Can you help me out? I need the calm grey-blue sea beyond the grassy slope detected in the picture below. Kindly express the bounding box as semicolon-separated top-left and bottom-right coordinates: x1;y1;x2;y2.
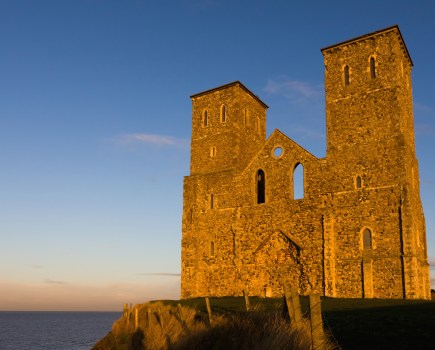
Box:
0;312;121;350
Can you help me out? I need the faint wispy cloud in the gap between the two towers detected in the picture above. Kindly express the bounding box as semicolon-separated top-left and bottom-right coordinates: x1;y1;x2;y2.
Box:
264;76;323;103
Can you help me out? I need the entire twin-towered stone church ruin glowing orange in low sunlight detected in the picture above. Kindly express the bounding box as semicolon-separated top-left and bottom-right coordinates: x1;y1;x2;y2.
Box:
181;26;430;299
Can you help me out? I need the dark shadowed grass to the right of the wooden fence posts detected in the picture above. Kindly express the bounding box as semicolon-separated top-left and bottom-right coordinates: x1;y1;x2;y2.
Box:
322;298;435;349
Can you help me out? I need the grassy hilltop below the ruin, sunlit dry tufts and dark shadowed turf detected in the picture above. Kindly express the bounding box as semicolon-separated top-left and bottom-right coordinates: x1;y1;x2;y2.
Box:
94;297;435;350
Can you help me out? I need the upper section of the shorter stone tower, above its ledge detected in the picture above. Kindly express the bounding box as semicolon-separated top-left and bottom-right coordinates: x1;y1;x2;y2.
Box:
190;81;267;175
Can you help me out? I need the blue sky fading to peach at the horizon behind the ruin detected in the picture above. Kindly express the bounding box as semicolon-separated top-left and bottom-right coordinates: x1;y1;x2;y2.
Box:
0;0;435;310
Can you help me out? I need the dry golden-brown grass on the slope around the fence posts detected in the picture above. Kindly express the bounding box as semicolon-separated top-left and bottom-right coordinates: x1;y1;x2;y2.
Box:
93;302;334;350
